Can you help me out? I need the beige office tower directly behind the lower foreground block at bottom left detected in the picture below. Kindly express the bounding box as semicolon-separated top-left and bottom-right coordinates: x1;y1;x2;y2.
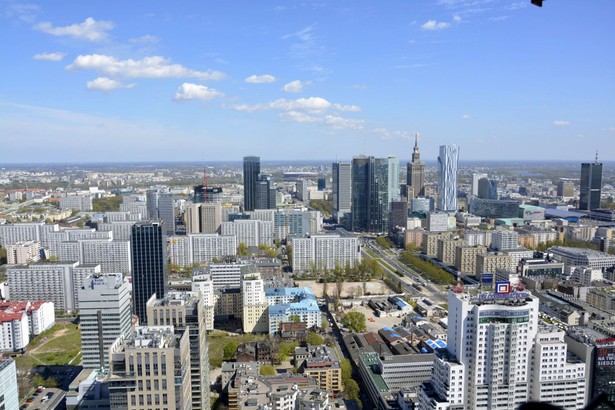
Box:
147;292;210;410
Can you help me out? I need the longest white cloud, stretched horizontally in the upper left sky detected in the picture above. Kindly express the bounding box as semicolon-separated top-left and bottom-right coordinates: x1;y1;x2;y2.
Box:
66;54;224;80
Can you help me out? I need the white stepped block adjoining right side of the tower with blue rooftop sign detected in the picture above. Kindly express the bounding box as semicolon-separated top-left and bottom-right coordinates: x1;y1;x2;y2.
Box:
530;326;589;409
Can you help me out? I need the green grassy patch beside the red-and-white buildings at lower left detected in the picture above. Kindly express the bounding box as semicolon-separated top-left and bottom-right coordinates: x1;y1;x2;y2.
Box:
15;323;81;372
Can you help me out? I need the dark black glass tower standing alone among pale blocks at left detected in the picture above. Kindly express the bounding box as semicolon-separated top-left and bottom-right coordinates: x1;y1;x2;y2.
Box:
130;222;167;324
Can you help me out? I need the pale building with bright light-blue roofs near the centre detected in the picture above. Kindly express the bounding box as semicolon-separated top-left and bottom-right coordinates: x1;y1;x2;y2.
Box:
265;287;322;334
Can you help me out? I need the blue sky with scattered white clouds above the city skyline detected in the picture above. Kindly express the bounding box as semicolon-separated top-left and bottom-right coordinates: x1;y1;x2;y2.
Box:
0;0;615;163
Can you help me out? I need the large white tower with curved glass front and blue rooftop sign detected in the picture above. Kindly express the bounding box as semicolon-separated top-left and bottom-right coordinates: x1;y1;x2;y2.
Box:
421;289;538;410
